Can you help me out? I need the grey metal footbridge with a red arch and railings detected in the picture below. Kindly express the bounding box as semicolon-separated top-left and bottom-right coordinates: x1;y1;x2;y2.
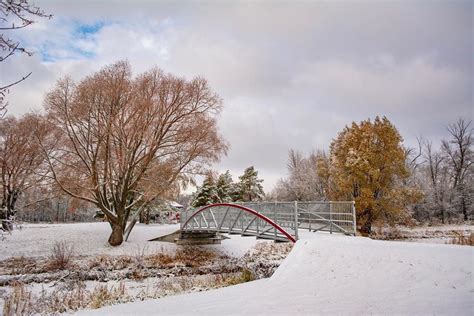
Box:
180;201;356;242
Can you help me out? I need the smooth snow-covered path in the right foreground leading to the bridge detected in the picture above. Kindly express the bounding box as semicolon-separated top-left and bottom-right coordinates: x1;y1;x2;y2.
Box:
85;233;474;315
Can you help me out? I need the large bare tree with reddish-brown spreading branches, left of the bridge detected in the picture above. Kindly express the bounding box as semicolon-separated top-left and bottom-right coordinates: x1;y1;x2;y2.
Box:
41;61;227;246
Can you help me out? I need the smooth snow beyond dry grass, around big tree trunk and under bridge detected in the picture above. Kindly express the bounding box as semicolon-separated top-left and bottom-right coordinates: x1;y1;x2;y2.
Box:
0;222;262;260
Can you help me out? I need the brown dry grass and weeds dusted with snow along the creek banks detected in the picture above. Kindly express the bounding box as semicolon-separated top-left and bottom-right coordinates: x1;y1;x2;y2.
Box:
0;243;292;315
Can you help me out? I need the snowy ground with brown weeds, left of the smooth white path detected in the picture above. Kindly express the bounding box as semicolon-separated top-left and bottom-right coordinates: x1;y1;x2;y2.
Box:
0;223;291;314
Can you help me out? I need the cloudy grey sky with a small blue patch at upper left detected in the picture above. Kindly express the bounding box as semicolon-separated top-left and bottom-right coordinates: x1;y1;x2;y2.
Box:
0;0;474;191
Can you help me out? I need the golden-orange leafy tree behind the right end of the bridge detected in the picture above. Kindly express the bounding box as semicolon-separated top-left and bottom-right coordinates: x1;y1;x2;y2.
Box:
330;117;419;234
